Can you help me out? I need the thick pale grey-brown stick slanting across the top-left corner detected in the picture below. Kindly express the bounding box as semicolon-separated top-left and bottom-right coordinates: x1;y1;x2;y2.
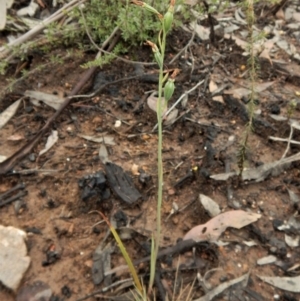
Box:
0;0;86;59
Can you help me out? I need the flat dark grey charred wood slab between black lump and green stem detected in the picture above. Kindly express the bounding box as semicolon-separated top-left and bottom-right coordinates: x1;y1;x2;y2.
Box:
105;163;142;204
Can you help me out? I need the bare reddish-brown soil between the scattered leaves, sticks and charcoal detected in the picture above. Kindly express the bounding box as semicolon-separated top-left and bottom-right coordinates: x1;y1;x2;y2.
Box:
0;1;300;301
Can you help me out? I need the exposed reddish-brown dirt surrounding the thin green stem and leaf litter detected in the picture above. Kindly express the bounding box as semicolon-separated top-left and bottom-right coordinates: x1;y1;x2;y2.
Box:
0;15;300;301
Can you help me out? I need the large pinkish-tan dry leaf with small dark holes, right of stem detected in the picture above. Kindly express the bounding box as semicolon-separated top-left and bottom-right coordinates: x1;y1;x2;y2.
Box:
183;210;261;242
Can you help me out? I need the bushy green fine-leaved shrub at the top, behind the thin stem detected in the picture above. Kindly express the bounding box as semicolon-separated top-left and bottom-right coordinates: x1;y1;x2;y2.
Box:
75;0;190;46
